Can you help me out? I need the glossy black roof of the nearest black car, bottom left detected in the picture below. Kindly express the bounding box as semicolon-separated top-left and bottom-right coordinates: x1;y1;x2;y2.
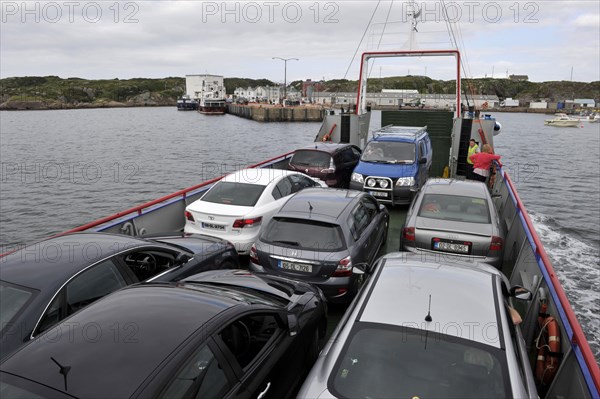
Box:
2;283;258;397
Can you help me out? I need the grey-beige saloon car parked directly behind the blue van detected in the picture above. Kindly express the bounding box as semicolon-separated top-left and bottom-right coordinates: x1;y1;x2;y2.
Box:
400;179;505;268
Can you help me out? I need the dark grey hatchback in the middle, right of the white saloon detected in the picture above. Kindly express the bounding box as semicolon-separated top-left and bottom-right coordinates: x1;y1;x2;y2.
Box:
249;188;389;303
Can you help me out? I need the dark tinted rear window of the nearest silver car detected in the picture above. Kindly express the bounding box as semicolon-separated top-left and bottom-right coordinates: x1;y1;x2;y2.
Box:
328;324;511;398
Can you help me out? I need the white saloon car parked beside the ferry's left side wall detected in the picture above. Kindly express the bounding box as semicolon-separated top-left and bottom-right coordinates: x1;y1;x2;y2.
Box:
184;168;327;255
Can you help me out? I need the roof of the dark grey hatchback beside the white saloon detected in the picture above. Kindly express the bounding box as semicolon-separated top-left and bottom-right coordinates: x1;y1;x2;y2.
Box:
275;188;364;221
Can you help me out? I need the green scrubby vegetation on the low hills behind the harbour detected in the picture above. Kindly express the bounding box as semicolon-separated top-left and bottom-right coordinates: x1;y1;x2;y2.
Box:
0;76;600;109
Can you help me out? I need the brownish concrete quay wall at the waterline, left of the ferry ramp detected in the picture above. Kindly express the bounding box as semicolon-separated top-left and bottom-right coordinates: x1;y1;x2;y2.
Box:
227;104;325;122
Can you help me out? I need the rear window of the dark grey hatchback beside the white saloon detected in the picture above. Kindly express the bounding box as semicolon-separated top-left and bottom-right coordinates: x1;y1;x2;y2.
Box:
261;217;346;251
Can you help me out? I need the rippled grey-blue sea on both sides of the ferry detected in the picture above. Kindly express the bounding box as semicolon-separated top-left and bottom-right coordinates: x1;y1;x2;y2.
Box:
0;107;600;359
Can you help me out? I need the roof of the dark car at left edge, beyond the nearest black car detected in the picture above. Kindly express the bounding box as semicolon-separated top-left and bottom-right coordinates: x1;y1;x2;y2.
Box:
0;233;152;289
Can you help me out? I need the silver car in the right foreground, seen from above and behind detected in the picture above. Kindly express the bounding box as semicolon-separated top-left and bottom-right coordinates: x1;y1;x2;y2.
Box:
298;252;538;399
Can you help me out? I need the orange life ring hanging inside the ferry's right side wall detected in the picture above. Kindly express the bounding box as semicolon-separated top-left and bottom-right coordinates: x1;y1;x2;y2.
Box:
535;316;562;386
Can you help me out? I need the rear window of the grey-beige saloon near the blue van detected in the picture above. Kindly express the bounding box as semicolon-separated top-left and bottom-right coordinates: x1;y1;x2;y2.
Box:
418;194;491;224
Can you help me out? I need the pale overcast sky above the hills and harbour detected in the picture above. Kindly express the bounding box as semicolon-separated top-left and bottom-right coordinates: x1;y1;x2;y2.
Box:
0;0;600;82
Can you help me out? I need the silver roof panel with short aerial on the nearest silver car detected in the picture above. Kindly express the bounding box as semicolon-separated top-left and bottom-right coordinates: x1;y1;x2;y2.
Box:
359;253;503;348
